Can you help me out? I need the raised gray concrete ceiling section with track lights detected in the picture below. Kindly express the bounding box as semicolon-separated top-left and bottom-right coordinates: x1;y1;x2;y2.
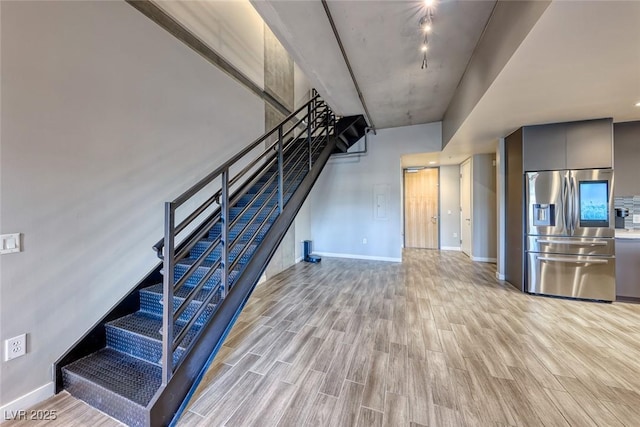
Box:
254;0;495;129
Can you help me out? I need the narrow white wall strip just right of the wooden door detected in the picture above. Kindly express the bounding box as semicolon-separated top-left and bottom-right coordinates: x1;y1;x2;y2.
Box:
440;165;460;249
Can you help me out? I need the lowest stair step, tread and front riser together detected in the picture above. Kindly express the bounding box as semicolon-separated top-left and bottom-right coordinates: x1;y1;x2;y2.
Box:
62;348;162;427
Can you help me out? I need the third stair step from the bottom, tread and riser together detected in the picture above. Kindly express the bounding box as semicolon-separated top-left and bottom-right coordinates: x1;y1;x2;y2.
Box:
140;283;221;325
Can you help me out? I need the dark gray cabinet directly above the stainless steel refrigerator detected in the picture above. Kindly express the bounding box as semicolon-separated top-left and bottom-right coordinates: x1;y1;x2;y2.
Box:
522;119;613;172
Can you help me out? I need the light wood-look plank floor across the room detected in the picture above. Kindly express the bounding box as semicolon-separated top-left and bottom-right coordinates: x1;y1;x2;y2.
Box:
11;250;640;427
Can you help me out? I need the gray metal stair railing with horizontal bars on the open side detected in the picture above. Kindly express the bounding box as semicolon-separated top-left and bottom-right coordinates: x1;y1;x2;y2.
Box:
158;93;335;385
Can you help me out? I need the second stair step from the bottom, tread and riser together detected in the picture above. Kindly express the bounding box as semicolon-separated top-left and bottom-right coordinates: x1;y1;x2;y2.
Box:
105;311;200;366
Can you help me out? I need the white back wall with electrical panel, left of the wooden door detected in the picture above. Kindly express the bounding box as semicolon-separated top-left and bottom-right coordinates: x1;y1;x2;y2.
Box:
310;122;442;260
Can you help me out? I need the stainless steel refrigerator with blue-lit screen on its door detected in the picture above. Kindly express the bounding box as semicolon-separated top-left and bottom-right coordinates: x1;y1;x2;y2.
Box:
525;169;616;301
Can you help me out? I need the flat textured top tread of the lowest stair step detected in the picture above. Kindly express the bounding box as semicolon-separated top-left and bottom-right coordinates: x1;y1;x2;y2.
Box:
63;348;162;407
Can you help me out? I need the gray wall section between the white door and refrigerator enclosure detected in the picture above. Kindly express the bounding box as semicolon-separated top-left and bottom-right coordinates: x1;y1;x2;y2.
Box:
471;153;498;262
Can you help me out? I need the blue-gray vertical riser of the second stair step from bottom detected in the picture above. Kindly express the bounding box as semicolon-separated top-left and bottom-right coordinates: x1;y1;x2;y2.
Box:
106;324;184;366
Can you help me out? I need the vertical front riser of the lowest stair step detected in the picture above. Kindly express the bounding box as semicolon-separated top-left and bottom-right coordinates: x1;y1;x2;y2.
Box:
62;368;147;427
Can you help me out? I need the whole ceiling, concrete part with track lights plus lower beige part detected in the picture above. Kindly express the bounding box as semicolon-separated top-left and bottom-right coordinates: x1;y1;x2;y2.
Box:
254;0;640;166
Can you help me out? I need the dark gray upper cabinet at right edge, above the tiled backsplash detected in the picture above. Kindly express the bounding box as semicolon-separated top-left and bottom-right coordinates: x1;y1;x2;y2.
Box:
613;122;640;197
